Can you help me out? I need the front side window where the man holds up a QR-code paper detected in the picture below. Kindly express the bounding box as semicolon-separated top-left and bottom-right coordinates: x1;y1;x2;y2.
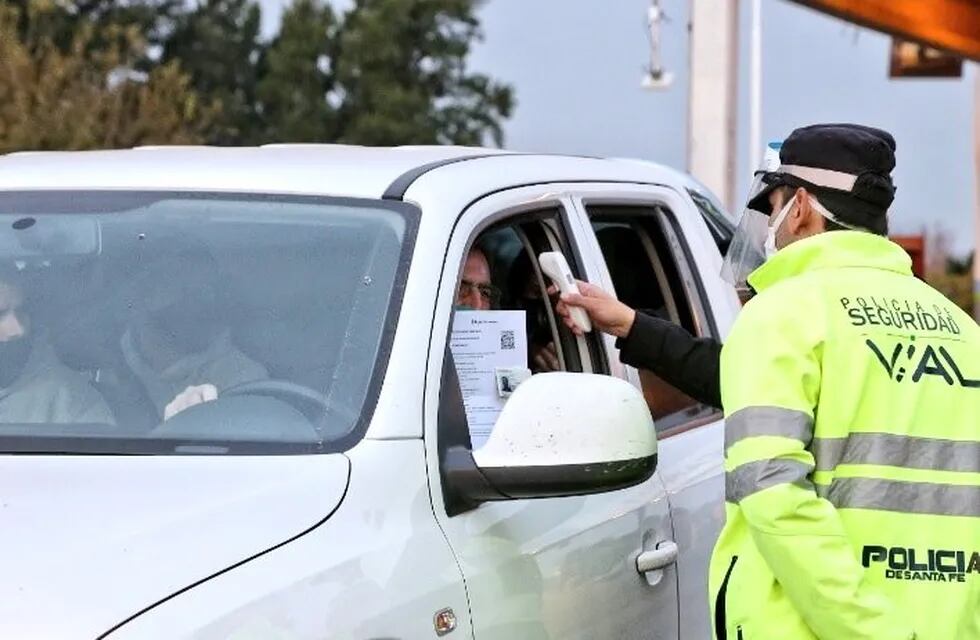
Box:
450;207;608;447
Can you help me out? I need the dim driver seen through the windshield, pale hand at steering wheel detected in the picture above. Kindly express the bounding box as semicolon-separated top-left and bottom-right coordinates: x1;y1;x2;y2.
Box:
121;252;268;420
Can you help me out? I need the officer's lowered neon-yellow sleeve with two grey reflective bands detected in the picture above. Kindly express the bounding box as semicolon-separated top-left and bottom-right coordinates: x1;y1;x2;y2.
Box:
721;291;912;640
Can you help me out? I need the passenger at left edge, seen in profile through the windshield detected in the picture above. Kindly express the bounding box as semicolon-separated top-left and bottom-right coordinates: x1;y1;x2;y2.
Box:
0;268;115;424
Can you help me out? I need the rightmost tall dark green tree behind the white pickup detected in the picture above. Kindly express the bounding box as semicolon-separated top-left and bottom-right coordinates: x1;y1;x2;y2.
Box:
334;0;513;146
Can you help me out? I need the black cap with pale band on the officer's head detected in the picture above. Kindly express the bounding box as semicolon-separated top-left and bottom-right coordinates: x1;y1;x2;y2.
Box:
748;124;895;232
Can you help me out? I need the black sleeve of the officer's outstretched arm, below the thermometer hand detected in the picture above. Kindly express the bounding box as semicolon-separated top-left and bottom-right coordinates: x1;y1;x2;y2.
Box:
616;311;721;409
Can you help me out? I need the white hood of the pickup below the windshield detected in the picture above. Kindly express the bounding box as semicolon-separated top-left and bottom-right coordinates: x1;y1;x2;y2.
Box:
0;454;349;639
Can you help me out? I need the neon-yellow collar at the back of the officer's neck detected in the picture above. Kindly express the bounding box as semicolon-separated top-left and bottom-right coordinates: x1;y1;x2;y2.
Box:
749;231;912;293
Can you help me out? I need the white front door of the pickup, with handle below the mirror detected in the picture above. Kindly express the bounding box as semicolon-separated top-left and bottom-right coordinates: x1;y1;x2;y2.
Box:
425;185;678;640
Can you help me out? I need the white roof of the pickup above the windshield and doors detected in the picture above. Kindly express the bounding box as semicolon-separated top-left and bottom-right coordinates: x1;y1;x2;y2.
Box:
0;144;685;199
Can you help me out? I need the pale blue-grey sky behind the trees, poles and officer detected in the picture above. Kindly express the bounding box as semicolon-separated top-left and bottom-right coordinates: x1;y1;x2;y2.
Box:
261;0;975;251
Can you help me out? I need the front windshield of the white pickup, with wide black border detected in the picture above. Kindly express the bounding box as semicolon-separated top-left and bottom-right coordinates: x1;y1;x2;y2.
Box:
0;191;417;454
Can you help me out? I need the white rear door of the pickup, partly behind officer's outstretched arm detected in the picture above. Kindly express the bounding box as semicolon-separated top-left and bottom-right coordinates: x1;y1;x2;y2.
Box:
573;185;737;638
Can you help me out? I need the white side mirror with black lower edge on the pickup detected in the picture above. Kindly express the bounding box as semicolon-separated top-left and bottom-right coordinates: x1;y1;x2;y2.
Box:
444;373;657;506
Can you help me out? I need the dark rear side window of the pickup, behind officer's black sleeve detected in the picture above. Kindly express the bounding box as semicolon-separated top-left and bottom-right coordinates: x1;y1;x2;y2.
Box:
586;204;718;436
